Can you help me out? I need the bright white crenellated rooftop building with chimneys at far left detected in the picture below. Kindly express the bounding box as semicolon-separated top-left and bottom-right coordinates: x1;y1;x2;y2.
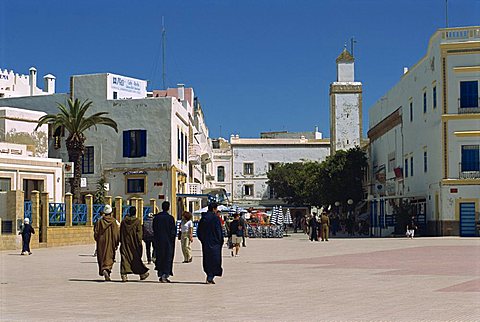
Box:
0;67;55;98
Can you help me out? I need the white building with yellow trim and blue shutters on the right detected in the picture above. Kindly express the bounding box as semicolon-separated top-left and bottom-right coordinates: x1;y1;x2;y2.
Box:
368;27;480;236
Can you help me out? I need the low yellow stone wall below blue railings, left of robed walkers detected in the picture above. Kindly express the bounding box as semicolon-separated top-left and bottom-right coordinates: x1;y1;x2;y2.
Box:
47;226;95;247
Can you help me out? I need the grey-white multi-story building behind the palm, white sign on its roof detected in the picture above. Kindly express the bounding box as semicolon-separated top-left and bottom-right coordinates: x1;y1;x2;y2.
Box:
0;73;211;216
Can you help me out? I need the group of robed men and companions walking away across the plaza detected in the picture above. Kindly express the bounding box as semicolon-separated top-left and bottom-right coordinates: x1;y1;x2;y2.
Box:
94;201;223;284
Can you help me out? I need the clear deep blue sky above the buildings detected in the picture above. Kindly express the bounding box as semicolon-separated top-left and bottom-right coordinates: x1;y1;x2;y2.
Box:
0;0;480;138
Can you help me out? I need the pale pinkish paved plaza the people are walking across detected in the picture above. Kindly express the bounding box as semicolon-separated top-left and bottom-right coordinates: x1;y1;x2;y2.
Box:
0;234;480;321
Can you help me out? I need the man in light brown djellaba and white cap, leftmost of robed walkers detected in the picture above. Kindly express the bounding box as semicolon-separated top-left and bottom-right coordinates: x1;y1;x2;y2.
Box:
94;205;120;281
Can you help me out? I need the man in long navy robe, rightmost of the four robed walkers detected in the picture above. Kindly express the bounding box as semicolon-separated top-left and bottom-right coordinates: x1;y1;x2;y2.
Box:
197;203;223;284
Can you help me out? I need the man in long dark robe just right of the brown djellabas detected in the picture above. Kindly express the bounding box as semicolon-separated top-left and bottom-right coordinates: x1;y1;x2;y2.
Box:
153;201;177;283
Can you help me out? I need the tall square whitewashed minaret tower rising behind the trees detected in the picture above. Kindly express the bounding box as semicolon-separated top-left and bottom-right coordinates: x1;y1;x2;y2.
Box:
330;48;362;155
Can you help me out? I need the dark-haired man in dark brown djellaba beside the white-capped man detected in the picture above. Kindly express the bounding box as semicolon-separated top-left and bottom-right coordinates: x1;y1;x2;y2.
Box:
120;207;148;282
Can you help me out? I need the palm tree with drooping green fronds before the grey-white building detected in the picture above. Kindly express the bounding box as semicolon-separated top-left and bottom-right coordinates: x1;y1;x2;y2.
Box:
35;99;118;202
